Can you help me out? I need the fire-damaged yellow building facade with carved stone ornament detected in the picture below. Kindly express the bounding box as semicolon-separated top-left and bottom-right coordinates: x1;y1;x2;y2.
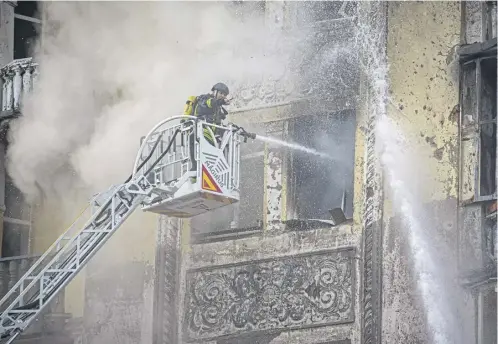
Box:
0;1;497;344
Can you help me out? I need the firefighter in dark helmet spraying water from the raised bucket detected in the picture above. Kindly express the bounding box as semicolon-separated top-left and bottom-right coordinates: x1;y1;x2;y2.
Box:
184;82;230;176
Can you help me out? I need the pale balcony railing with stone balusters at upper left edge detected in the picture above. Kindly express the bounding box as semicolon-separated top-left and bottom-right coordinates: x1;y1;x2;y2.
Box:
0;57;38;115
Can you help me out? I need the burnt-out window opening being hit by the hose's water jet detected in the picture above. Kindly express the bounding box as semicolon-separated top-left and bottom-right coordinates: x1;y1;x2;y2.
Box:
288;111;356;220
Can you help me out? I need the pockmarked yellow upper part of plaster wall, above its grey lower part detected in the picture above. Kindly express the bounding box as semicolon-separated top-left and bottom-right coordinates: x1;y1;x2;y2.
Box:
388;2;461;200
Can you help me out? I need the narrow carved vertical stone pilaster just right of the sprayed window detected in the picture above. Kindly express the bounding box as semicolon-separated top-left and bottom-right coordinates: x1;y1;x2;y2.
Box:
358;2;387;344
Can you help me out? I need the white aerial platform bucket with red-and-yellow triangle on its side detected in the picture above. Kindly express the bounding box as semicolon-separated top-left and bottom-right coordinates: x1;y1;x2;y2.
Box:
135;116;242;218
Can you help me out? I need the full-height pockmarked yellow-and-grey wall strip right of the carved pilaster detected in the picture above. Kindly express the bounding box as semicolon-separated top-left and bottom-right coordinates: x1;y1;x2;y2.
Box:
382;2;474;343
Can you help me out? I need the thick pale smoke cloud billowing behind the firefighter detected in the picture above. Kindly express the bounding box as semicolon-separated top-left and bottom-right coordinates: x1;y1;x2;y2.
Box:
8;2;291;202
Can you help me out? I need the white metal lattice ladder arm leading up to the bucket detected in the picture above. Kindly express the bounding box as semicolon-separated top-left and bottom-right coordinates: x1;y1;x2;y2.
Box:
0;176;151;344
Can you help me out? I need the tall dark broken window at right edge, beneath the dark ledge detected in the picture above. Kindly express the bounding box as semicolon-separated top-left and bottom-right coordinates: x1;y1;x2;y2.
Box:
462;56;497;201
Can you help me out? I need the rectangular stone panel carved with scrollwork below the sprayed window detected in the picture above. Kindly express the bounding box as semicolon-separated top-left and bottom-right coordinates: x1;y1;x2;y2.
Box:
183;248;355;342
